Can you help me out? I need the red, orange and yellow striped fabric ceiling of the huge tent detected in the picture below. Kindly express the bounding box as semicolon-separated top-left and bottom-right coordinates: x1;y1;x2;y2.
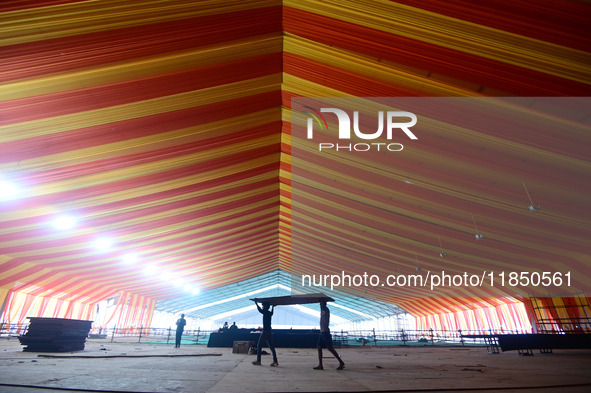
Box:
0;0;591;314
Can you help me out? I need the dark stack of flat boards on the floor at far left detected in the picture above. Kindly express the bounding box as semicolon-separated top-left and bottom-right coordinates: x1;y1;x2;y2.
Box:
18;317;92;352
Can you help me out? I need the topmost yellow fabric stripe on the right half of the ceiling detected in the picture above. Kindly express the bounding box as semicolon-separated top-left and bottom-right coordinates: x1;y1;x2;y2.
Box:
284;0;591;83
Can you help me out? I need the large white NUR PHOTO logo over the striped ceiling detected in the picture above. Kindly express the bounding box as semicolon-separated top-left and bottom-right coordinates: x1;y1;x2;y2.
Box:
304;106;418;151
